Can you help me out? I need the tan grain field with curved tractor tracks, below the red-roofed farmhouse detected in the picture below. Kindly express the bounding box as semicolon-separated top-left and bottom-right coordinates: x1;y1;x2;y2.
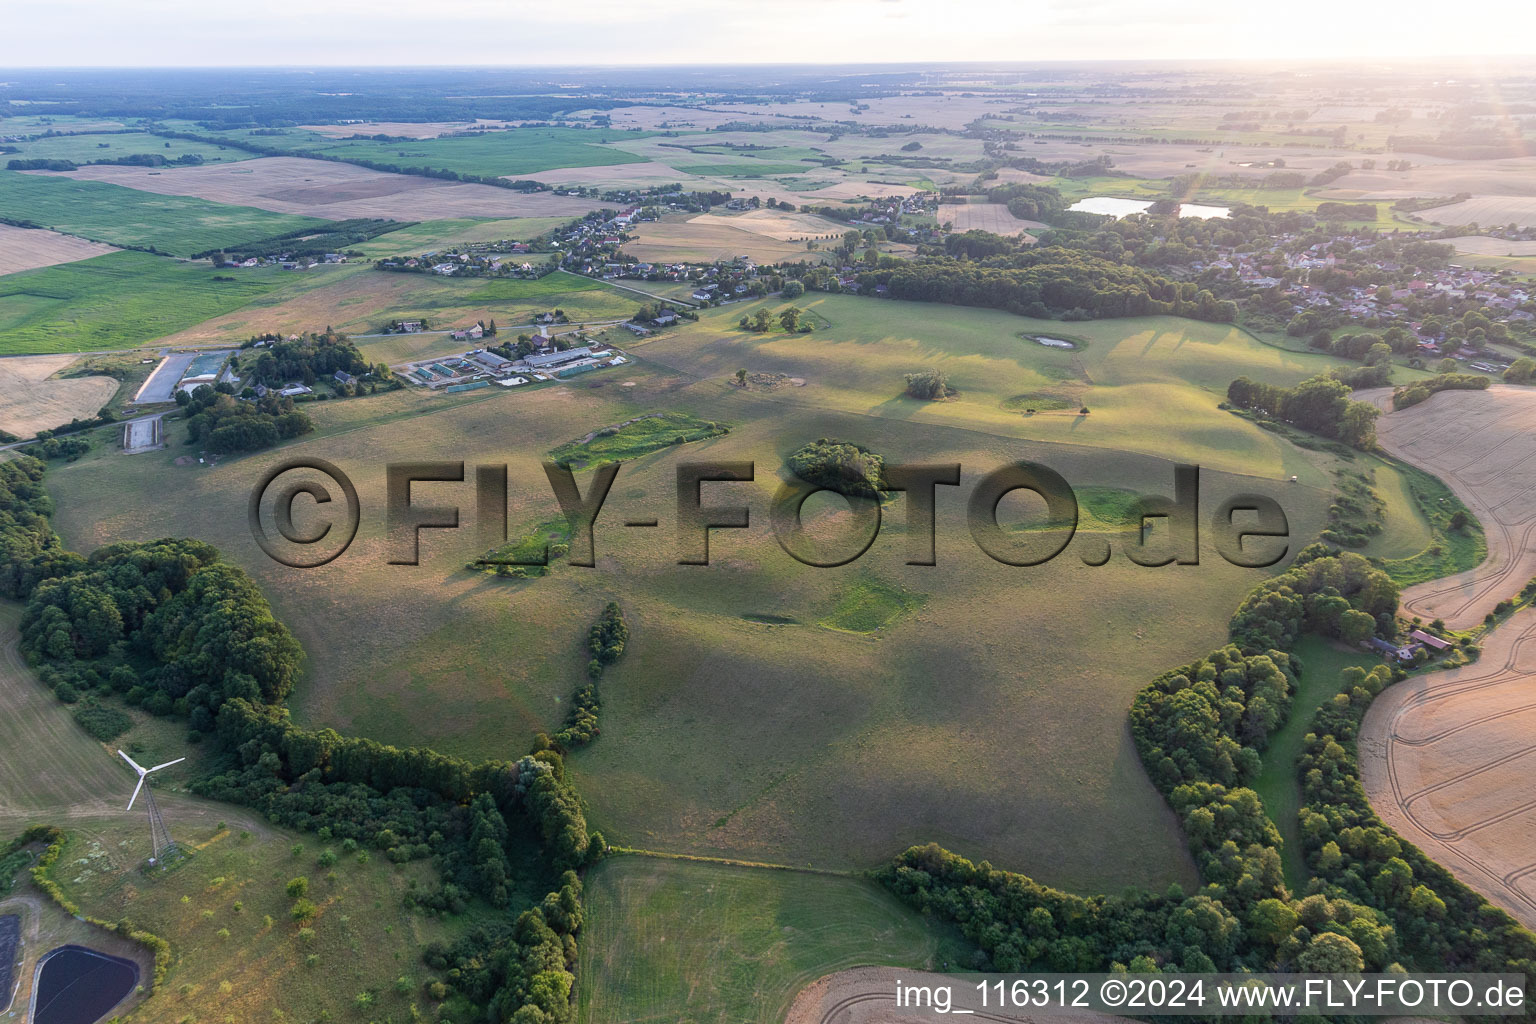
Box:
1359;608;1536;927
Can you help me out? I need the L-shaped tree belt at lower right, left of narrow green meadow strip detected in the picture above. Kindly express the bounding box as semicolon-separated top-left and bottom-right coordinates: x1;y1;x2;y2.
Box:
879;545;1431;972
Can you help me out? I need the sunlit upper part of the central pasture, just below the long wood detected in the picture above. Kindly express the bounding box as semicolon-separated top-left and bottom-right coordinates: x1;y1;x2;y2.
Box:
639;295;1370;475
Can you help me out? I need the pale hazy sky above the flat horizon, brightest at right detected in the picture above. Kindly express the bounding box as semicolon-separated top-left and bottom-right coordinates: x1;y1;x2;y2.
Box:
9;0;1536;68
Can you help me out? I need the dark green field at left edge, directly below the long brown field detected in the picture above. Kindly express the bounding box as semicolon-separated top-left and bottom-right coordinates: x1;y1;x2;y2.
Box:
0;170;321;256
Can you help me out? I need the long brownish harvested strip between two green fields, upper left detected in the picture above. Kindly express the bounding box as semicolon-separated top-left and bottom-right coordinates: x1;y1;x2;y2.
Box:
29;157;602;221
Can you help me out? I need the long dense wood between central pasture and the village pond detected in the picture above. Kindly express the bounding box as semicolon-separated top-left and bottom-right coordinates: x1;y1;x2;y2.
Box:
859;243;1238;324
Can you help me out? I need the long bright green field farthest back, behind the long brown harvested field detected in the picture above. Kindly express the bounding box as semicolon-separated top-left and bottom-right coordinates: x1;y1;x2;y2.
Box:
185;127;647;177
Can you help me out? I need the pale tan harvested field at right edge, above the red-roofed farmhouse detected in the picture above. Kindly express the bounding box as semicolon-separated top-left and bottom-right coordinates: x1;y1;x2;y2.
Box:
1362;384;1536;629
